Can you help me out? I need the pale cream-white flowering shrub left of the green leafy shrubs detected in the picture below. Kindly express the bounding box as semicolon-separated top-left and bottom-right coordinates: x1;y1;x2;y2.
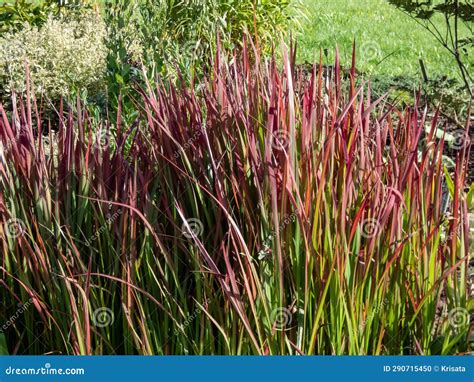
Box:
0;10;107;100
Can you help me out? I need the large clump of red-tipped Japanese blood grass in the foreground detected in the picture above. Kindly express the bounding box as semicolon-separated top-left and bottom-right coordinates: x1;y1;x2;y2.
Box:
0;44;472;354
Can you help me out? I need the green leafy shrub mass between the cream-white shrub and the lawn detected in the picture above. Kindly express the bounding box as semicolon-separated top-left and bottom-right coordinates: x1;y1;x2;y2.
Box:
105;0;298;122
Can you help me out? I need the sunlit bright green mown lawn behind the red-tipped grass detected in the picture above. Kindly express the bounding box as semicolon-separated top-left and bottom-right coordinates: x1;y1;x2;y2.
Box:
298;0;467;83
